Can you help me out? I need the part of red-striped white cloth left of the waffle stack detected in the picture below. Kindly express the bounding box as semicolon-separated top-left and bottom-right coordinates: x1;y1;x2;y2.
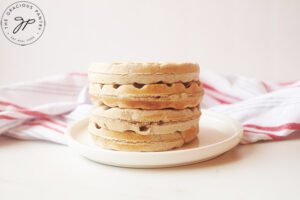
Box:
0;73;91;144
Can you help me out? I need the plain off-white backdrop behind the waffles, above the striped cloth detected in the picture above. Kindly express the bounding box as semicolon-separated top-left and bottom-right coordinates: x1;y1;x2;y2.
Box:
0;0;300;84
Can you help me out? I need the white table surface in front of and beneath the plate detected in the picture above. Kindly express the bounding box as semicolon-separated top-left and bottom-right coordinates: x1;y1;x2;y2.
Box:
0;134;300;200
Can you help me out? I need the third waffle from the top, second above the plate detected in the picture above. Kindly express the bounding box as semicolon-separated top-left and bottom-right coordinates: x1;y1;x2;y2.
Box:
90;106;200;135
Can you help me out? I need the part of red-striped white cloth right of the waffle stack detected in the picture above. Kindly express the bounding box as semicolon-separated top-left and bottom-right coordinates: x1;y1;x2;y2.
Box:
200;70;300;144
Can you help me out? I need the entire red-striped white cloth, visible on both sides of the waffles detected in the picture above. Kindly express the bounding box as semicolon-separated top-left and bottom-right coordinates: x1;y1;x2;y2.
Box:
0;69;300;144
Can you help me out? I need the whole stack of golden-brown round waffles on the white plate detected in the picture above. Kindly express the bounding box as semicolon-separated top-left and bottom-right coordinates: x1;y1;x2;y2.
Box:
88;63;203;151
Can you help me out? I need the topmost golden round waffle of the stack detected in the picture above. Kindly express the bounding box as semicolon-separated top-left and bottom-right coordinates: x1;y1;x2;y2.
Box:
88;62;199;84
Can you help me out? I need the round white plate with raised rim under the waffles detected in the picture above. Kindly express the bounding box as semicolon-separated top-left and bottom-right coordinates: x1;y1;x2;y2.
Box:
67;110;243;168
